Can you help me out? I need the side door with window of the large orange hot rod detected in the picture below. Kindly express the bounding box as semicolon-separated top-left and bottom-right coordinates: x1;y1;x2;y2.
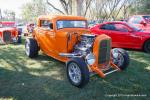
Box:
38;20;55;54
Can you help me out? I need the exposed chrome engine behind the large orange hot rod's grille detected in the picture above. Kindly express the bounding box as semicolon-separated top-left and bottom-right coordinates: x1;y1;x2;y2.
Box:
74;34;96;56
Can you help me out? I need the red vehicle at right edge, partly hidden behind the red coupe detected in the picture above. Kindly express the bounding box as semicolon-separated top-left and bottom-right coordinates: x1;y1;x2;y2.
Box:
128;15;150;32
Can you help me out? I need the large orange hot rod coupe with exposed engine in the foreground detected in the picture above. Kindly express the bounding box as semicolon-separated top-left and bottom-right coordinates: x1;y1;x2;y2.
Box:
25;15;129;88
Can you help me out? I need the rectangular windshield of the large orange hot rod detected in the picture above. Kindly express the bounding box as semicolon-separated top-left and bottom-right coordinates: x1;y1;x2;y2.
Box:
57;20;87;29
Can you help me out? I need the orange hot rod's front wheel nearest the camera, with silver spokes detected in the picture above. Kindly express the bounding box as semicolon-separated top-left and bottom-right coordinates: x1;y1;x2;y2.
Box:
67;58;90;88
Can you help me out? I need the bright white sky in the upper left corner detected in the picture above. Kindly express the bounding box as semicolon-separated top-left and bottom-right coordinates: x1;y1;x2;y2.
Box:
0;0;31;17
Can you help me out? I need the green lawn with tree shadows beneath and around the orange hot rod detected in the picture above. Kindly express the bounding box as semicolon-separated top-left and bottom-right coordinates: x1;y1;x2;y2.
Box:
0;45;150;100
